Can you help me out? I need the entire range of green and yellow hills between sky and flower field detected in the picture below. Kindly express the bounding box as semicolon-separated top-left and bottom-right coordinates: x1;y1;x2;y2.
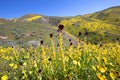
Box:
0;7;120;45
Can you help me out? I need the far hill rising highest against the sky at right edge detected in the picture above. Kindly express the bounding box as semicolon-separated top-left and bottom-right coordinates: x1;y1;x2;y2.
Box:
85;6;120;25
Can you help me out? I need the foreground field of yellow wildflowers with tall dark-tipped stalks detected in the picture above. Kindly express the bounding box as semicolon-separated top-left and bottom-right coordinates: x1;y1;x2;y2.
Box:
0;27;120;80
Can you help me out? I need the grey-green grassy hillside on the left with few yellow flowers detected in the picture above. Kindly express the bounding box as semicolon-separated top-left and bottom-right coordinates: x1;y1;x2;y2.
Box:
0;21;77;46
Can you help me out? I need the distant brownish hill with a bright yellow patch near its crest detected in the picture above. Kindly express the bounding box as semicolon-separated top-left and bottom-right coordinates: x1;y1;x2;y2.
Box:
17;14;69;26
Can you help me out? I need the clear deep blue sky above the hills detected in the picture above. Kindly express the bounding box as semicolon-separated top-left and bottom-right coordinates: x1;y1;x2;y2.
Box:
0;0;120;18
